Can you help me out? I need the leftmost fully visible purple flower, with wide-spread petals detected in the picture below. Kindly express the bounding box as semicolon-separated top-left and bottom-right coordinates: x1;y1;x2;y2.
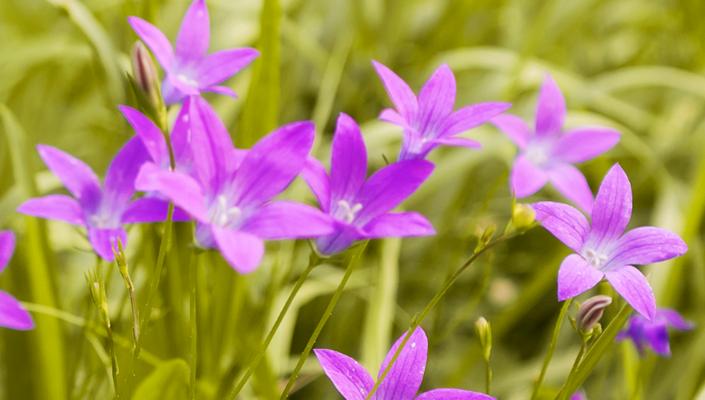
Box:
17;138;167;261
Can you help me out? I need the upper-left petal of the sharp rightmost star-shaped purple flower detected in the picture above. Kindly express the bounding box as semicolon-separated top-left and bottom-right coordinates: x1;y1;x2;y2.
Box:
532;201;590;252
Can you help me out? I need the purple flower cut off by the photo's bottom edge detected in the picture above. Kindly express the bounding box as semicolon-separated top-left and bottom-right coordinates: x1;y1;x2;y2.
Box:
314;328;494;400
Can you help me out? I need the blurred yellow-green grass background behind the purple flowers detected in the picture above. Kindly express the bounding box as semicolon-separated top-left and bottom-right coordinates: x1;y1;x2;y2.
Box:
0;0;705;400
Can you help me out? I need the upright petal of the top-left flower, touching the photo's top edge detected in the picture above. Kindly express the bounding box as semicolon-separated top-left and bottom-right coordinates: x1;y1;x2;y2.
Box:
176;0;210;62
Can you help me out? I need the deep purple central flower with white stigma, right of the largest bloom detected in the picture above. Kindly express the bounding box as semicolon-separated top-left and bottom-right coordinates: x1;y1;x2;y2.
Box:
303;114;435;254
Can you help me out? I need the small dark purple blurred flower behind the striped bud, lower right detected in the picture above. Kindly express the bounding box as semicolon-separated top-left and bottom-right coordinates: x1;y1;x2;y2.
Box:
617;308;693;357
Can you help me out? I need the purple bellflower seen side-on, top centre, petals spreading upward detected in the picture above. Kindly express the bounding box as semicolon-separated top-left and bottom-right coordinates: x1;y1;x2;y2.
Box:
372;61;511;160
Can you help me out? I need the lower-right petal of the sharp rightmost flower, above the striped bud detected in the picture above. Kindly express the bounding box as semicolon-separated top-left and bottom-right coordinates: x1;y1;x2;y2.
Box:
605;265;656;320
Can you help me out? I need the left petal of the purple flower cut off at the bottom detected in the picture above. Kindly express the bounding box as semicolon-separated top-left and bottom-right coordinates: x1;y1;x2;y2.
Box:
313;349;374;400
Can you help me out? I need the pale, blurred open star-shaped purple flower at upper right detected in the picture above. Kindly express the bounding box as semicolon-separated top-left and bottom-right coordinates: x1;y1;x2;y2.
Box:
492;75;620;213
